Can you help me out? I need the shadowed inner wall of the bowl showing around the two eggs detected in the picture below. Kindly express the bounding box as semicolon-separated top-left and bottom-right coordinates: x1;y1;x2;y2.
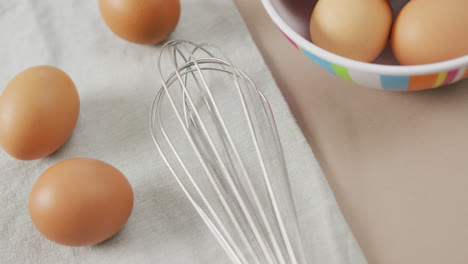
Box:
270;0;410;65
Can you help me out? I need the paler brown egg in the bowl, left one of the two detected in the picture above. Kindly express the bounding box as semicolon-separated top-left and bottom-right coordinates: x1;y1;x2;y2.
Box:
310;0;393;62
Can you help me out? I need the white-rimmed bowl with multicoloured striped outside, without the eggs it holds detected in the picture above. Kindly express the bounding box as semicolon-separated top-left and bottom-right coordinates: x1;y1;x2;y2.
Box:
262;0;468;91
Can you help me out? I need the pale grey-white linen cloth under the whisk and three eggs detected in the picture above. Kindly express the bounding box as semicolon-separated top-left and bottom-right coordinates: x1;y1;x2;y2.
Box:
0;0;366;264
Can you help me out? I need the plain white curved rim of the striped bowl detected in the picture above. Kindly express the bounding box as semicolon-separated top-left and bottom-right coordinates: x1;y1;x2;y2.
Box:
261;0;468;76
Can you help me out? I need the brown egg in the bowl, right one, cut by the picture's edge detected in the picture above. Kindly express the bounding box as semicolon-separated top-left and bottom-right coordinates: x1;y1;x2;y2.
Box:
392;0;468;65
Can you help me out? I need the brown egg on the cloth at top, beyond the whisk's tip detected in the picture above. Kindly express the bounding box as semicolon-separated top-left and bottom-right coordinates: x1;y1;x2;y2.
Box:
99;0;180;44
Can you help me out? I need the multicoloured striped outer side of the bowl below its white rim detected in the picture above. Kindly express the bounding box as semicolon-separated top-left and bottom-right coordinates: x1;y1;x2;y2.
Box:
282;32;468;91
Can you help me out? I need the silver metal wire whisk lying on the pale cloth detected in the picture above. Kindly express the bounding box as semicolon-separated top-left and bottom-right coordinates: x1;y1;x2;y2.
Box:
150;41;305;264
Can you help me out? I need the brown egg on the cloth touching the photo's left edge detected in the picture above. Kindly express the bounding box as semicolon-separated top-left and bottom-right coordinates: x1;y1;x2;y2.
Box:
0;66;80;160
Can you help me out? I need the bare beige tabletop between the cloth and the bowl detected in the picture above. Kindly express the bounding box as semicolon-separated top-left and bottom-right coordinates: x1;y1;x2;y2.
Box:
235;0;468;264
